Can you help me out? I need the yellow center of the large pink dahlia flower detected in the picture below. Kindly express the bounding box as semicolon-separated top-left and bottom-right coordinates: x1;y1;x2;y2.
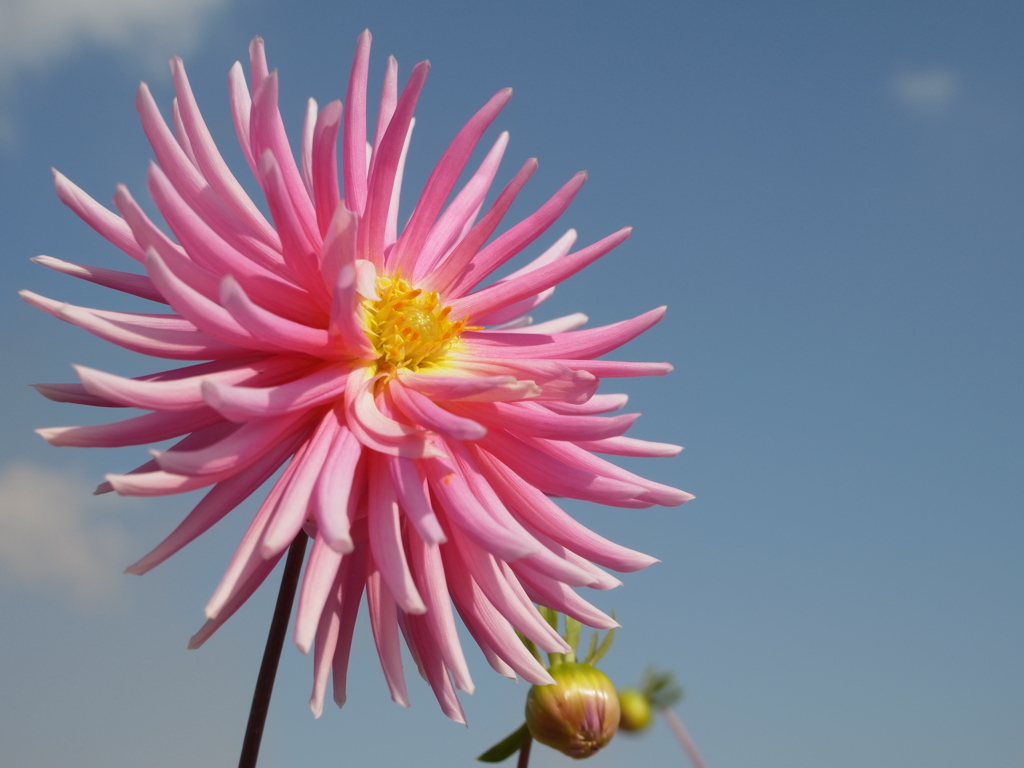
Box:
362;275;466;374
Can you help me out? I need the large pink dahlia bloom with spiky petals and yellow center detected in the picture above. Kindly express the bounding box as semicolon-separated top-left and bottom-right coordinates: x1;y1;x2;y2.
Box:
23;32;691;722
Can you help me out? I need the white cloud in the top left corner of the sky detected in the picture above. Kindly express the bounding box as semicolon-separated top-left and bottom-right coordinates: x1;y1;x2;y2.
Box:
0;0;228;85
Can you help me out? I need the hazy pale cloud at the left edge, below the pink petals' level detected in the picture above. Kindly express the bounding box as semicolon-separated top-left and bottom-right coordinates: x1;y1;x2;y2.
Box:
0;464;128;603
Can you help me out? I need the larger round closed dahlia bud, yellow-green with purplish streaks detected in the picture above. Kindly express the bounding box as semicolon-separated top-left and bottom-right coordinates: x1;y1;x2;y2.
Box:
526;662;620;760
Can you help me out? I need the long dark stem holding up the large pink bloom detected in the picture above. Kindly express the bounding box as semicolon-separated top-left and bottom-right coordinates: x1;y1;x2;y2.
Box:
239;530;309;768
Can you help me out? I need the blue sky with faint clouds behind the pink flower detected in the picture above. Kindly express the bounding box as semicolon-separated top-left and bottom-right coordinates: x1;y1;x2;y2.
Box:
0;0;1024;768
